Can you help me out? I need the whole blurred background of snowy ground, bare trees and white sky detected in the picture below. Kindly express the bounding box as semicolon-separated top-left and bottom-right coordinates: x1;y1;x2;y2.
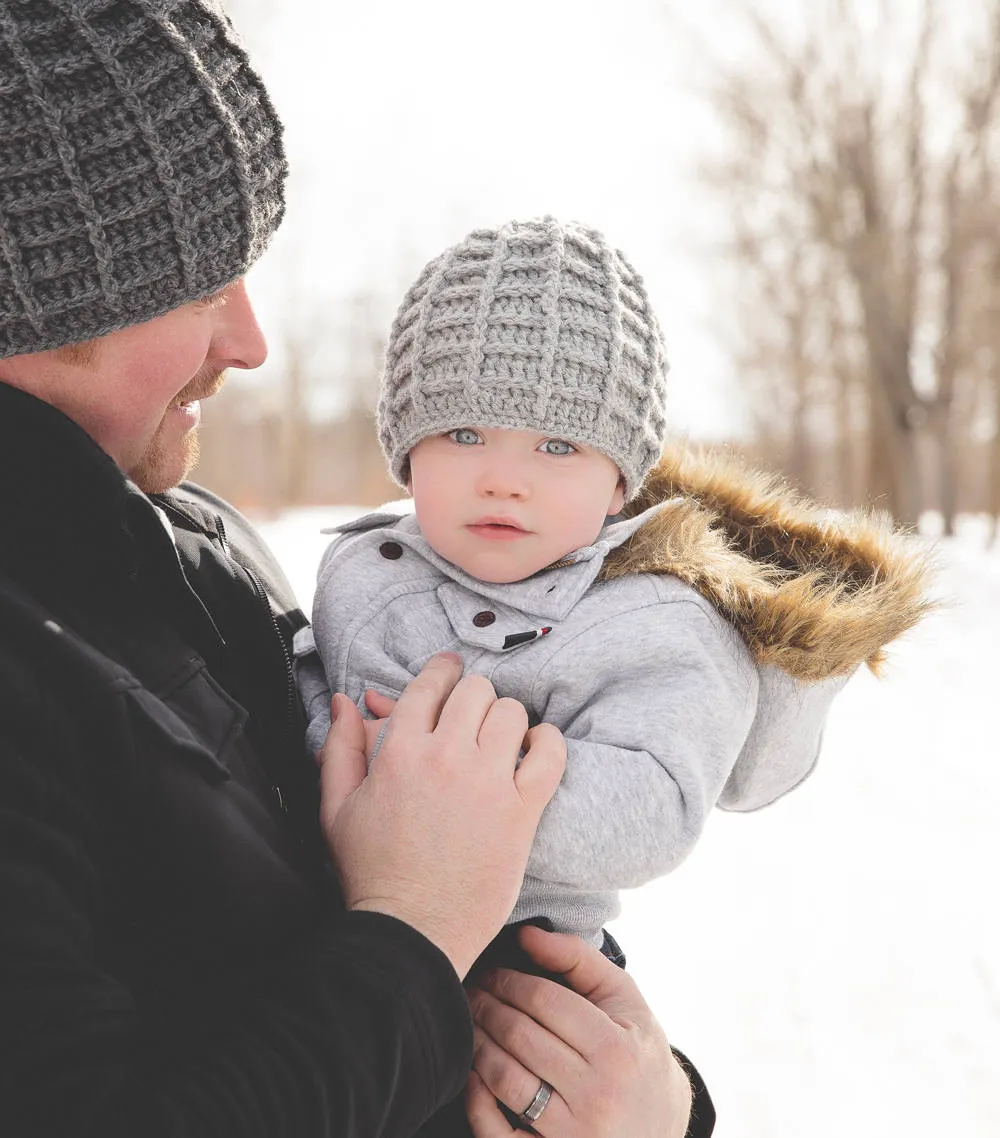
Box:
207;0;1000;1138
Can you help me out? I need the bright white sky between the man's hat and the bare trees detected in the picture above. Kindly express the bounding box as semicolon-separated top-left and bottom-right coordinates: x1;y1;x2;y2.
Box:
235;0;750;434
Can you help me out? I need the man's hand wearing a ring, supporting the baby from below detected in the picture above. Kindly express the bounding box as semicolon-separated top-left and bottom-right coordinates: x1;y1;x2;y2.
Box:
465;926;691;1138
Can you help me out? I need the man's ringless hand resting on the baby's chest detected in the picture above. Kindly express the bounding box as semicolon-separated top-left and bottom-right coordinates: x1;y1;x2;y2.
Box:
320;653;565;976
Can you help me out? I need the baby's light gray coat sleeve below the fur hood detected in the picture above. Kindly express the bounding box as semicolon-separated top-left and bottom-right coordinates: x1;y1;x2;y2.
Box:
528;600;758;890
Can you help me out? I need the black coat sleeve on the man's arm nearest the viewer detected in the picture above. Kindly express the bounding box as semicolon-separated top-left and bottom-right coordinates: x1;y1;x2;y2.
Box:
0;650;472;1138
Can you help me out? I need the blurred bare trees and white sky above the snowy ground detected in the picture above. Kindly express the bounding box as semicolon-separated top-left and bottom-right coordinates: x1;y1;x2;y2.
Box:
199;0;1000;539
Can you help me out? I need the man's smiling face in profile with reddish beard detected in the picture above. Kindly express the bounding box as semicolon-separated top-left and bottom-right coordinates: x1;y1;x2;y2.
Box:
0;280;267;494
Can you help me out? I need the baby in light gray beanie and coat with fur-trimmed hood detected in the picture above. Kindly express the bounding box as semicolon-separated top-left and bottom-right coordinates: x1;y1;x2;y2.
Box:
296;218;924;956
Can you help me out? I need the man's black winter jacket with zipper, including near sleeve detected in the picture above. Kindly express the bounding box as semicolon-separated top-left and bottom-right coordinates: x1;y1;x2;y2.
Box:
0;384;472;1138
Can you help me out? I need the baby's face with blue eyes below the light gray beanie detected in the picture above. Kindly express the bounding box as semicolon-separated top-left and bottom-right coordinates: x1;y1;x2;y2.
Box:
410;427;623;583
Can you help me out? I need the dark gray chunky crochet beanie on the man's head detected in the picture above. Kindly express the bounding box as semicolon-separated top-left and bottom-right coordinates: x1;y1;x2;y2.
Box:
0;0;286;358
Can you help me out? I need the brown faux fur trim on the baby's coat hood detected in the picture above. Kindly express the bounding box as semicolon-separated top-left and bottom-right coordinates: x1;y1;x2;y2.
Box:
601;447;933;681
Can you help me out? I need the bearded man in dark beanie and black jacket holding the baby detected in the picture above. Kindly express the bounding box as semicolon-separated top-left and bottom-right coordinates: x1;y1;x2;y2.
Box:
0;0;710;1138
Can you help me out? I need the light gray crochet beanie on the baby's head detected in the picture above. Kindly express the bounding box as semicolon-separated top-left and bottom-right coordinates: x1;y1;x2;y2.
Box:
378;217;667;498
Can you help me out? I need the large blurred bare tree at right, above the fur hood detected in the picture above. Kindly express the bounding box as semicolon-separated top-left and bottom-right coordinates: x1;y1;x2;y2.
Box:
708;0;1000;528
